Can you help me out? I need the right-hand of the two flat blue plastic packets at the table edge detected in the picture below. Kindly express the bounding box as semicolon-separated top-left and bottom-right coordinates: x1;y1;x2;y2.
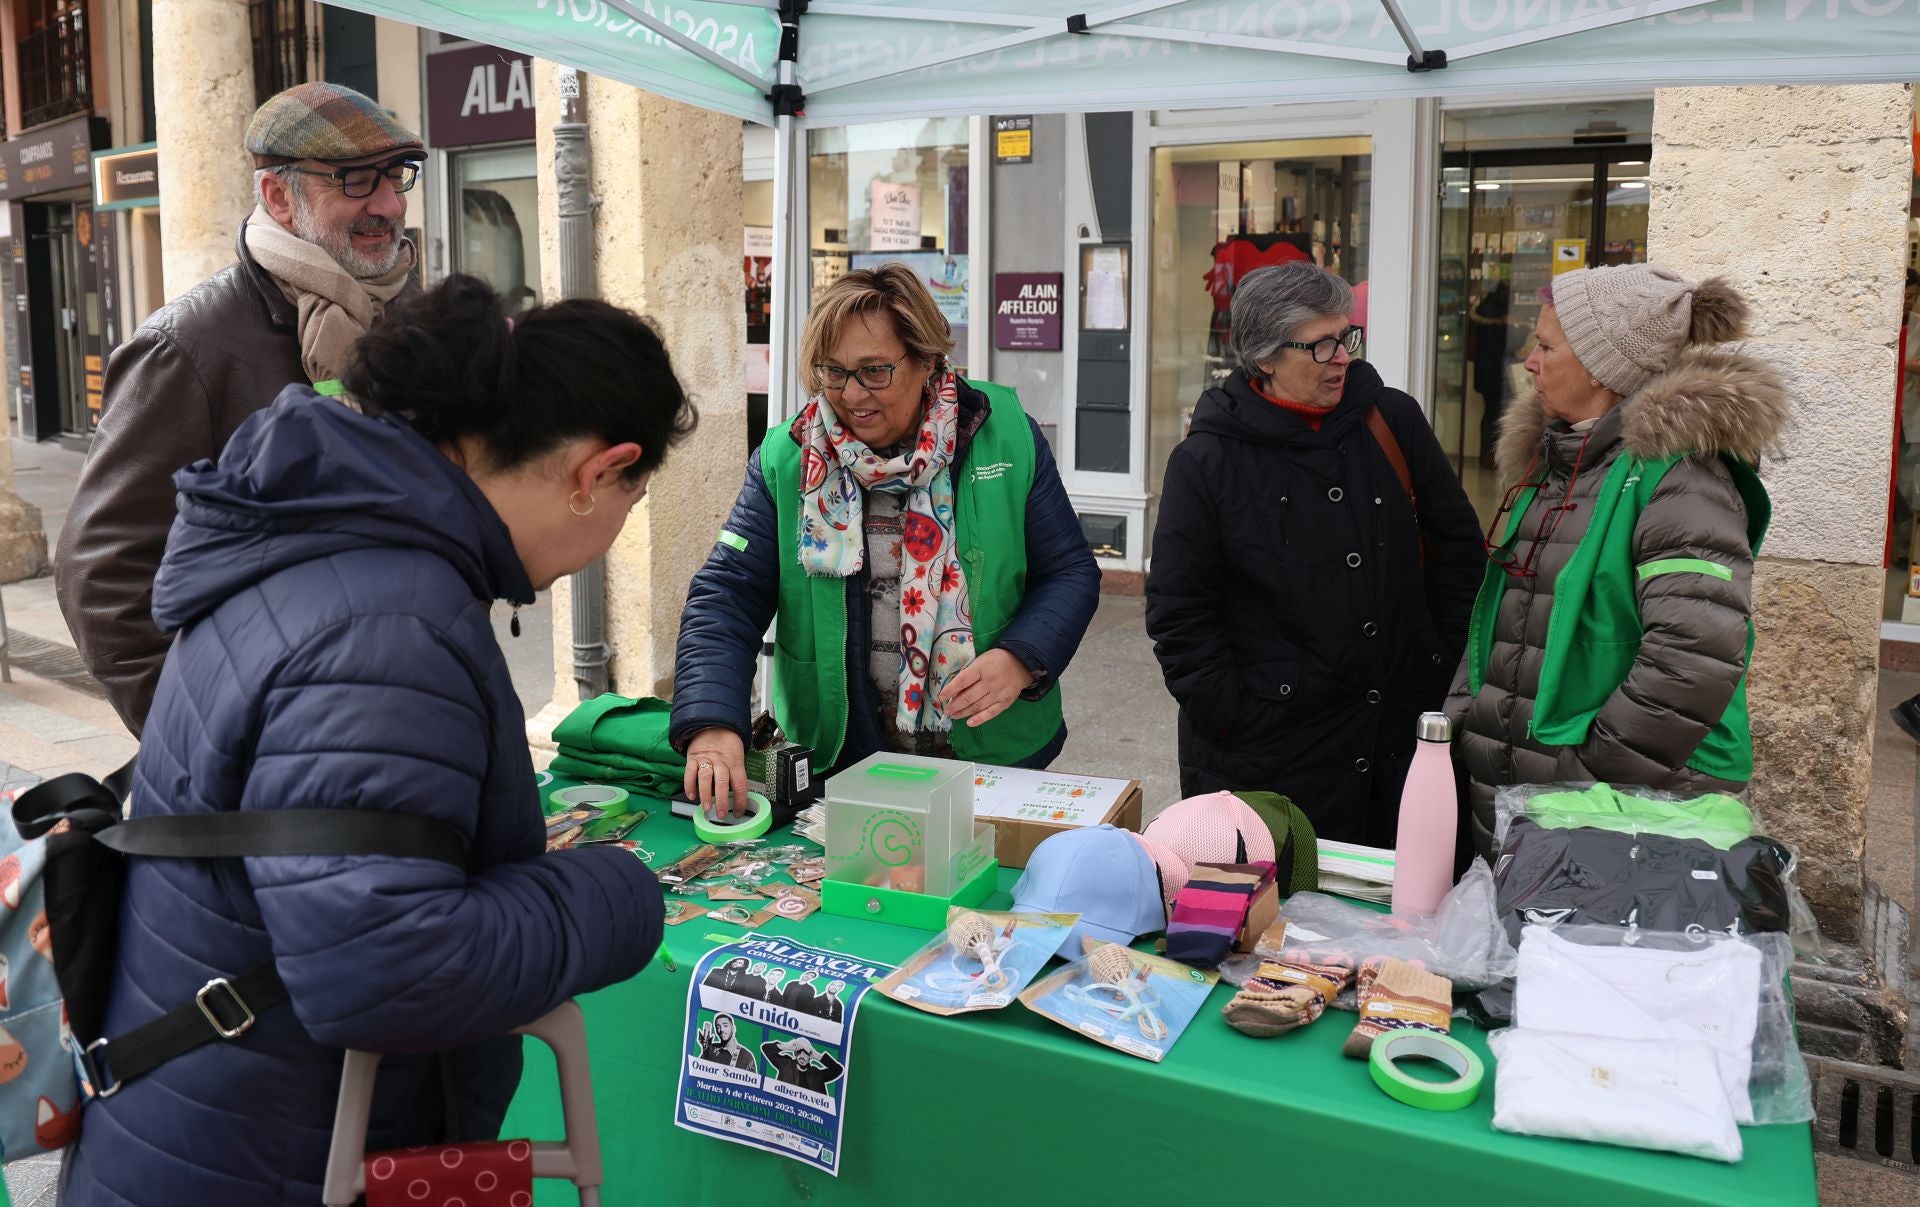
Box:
1020;942;1219;1063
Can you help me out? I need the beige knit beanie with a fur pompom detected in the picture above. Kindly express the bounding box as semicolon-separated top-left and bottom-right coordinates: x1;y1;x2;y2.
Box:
1551;265;1747;397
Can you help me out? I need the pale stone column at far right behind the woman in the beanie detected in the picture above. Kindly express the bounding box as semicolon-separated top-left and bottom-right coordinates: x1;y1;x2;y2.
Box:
1647;84;1912;940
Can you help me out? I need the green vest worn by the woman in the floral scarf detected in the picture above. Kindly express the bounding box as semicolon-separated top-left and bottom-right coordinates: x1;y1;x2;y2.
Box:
760;382;1060;768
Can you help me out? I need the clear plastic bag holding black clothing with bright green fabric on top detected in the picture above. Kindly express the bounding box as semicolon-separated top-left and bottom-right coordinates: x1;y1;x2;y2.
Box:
1494;783;1824;961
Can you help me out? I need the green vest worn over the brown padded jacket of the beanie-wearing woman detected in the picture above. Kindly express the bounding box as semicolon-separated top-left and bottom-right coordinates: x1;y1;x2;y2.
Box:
1467;455;1772;783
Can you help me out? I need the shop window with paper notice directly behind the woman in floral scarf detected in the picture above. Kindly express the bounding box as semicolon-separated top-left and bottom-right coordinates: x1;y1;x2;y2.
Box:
806;117;968;370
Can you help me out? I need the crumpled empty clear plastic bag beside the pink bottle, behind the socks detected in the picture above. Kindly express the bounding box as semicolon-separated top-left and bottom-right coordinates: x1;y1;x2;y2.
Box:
1221;860;1517;1009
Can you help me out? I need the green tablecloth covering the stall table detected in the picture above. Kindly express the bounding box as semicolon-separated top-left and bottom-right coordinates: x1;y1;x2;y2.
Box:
503;804;1816;1207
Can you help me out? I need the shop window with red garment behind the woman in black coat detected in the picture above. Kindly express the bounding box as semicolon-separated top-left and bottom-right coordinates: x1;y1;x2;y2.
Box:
1146;138;1373;497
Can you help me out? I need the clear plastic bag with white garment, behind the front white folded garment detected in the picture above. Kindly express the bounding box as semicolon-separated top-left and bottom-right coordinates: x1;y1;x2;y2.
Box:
1513;927;1812;1124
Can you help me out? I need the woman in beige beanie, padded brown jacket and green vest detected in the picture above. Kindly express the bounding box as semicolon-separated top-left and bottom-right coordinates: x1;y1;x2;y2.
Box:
1448;265;1788;856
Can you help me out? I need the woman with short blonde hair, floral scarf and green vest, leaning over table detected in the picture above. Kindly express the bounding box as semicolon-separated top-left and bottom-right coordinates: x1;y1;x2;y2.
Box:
670;263;1100;812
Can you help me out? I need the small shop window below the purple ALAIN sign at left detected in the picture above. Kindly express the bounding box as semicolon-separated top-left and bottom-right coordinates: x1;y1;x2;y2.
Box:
447;144;540;311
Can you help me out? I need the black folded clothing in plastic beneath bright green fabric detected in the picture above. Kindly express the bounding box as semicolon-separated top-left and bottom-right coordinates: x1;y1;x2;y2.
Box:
1494;817;1793;944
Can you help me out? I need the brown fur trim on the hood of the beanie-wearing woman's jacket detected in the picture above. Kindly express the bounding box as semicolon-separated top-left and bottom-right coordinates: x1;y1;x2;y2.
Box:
1496;345;1788;482
